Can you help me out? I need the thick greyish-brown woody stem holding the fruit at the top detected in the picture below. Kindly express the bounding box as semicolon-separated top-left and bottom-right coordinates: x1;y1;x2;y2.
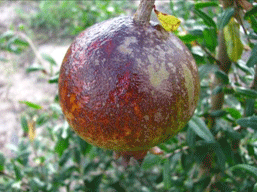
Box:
133;0;155;25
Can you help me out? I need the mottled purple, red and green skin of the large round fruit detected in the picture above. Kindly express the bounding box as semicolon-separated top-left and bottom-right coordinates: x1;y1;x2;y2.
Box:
59;17;200;156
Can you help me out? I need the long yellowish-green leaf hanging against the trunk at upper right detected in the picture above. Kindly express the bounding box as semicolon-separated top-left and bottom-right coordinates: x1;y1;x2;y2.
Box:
224;17;244;62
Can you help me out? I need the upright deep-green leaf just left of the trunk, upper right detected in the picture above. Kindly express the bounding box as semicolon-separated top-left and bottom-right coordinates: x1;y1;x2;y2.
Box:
203;28;218;52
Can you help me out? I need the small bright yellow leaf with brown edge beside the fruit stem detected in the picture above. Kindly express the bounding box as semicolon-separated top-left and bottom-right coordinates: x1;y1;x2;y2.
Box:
154;6;181;31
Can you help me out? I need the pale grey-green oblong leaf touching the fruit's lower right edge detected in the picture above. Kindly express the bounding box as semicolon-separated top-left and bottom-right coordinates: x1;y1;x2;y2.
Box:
188;117;215;143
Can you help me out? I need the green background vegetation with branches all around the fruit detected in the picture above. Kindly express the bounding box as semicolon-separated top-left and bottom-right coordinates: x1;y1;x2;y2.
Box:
0;0;257;192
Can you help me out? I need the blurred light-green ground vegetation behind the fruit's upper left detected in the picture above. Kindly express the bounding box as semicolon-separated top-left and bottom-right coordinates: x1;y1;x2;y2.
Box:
17;0;131;37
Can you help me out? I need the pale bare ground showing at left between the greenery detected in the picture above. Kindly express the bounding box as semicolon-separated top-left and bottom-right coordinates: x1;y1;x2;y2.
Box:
0;1;71;156
